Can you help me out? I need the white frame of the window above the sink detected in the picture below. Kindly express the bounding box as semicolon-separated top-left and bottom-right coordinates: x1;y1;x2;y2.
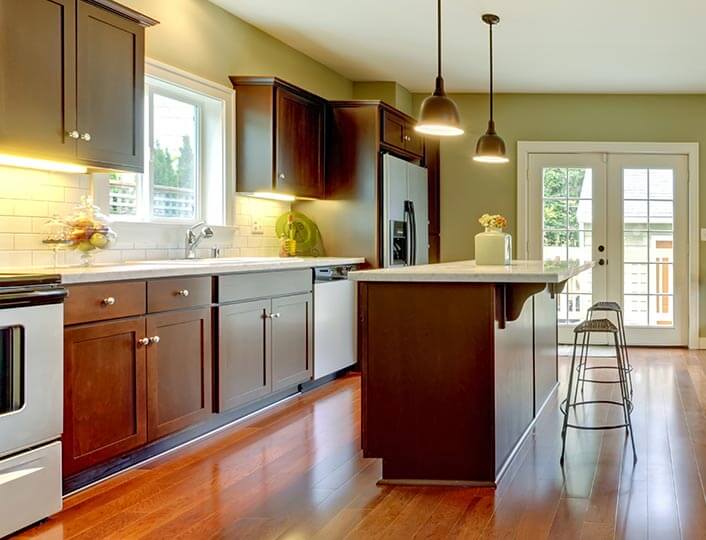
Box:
93;58;235;228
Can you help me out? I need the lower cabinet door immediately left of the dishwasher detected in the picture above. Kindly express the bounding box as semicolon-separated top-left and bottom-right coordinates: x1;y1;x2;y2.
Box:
270;294;312;391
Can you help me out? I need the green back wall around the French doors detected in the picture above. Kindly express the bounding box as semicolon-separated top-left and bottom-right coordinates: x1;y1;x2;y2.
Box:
413;90;706;336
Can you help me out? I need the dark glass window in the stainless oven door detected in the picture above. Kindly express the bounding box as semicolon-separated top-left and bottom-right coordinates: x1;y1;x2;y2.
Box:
0;326;25;415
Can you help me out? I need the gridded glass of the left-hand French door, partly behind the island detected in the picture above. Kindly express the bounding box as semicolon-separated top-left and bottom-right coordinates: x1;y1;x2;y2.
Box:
542;167;593;324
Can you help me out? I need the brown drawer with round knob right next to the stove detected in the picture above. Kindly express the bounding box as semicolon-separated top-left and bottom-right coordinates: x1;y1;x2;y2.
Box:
64;281;146;324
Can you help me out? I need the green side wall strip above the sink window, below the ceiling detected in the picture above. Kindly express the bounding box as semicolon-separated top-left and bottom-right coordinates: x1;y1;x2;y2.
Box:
121;0;353;99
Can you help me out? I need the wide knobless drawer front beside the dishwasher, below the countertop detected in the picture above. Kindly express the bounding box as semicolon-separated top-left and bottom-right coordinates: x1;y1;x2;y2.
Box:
218;268;313;302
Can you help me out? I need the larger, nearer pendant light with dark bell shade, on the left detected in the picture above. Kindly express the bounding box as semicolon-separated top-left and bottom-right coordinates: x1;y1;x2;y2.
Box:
414;0;463;137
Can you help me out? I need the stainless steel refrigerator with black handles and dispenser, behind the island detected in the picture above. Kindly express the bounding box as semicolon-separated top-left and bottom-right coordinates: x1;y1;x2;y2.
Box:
382;154;429;267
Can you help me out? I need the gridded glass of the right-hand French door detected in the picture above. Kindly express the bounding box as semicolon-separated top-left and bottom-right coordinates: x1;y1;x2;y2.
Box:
623;169;674;327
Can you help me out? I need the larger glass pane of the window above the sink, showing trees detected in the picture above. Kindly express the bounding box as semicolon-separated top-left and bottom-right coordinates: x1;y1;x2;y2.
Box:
150;92;199;220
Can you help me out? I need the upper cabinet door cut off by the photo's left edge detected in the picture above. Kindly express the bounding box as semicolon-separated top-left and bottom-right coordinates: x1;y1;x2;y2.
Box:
0;0;76;159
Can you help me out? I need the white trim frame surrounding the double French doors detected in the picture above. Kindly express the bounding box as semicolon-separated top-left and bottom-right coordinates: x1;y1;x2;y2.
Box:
516;141;706;349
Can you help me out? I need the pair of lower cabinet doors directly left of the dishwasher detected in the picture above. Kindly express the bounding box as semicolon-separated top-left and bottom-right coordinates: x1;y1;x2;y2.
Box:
218;293;313;411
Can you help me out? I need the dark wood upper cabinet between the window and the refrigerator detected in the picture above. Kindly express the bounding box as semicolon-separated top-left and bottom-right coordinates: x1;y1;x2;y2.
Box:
230;76;326;199
